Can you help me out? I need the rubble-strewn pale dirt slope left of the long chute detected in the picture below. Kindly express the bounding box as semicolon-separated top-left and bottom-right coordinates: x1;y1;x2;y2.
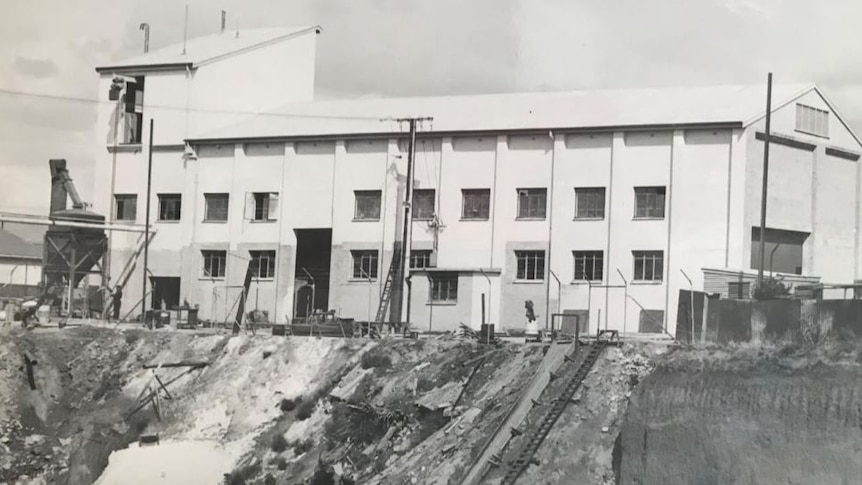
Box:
0;328;542;485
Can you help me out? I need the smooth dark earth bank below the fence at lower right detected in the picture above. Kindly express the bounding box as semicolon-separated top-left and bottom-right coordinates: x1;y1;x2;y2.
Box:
619;344;862;485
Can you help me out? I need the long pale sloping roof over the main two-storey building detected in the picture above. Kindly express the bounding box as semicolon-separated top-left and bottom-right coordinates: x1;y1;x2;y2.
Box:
189;84;849;142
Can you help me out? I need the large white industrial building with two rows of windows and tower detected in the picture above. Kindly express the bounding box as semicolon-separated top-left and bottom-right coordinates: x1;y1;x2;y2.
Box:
94;28;862;333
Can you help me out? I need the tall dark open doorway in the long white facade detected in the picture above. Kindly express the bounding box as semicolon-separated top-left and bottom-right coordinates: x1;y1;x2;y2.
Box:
293;229;332;319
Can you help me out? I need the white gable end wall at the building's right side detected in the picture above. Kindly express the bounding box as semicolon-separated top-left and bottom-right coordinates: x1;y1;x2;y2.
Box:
739;91;862;283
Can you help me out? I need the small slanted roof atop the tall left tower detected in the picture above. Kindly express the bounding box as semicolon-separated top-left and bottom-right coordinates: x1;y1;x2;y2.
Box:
96;26;320;72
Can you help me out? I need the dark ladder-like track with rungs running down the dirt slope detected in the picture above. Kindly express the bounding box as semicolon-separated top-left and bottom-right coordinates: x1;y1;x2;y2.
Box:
500;339;608;485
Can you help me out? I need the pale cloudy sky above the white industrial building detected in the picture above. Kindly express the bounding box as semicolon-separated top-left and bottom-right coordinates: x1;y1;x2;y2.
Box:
0;0;862;238
